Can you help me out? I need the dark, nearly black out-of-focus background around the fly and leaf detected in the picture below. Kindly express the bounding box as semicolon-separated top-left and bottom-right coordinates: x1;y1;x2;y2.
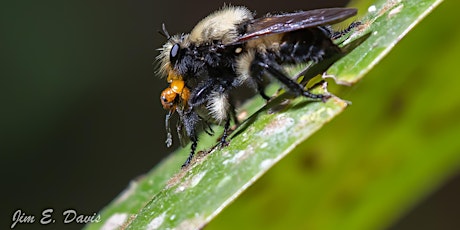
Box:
0;0;460;229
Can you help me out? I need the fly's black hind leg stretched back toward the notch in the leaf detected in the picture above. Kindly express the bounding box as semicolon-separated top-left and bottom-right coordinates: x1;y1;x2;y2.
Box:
256;61;330;101
